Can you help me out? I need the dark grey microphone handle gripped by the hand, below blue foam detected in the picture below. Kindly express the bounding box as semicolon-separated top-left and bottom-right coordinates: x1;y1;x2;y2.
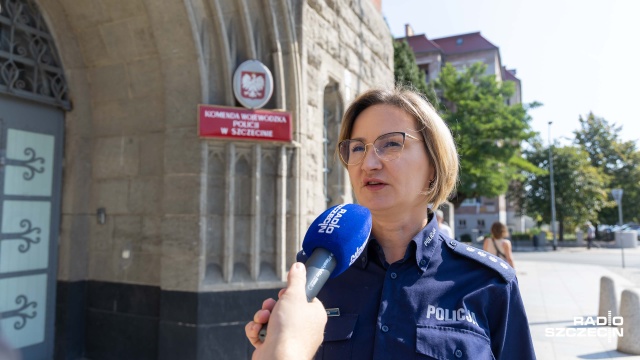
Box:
258;248;337;342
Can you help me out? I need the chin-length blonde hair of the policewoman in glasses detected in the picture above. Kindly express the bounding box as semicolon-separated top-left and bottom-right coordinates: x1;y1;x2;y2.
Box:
336;87;459;209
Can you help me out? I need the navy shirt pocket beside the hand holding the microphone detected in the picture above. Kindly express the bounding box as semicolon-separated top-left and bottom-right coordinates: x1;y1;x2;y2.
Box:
316;314;358;359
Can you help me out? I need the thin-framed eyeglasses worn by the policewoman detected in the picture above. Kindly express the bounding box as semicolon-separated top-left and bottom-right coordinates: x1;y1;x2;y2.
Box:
338;131;420;165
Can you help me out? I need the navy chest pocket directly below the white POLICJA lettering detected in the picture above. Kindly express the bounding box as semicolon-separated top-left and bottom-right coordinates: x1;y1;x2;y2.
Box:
416;325;495;360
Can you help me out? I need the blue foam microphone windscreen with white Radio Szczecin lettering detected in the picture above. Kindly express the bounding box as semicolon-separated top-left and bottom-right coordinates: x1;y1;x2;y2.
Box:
302;204;371;278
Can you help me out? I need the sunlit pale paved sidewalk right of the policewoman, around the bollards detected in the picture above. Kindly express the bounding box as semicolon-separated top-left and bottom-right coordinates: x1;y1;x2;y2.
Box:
516;260;640;360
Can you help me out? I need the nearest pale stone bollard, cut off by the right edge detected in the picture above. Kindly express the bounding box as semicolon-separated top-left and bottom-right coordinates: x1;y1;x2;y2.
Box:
617;289;640;355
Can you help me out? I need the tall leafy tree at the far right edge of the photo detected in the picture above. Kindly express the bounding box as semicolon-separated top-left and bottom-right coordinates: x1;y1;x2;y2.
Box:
574;113;640;224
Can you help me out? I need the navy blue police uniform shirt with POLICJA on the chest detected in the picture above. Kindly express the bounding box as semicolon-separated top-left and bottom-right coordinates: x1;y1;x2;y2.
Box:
298;216;535;360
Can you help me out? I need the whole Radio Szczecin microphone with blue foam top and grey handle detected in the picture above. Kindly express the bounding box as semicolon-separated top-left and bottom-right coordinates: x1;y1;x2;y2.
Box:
258;204;371;342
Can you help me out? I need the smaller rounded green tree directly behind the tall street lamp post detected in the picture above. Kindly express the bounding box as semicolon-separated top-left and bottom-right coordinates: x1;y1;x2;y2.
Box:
520;143;607;240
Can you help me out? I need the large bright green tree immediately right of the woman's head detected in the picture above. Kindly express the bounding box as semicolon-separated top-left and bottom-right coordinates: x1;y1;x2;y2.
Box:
433;63;540;208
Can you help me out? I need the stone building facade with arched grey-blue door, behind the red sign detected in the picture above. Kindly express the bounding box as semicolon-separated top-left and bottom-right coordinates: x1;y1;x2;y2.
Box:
0;0;393;360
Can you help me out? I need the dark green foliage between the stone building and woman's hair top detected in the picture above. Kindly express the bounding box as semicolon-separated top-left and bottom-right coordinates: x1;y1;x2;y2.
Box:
393;39;435;101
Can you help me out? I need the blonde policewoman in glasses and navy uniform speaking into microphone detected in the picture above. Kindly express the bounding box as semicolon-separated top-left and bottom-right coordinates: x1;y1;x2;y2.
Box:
308;89;535;360
